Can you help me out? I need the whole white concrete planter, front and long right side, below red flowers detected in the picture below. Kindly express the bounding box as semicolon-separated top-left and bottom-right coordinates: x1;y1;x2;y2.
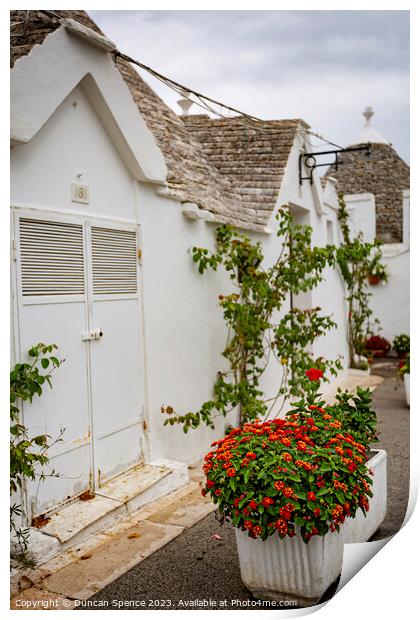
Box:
235;450;386;607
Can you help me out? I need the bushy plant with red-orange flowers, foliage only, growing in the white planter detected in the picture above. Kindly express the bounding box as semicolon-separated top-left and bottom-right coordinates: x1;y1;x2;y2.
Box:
202;369;375;542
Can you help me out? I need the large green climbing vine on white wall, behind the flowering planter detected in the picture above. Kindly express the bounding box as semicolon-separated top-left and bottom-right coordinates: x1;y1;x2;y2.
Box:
162;207;341;432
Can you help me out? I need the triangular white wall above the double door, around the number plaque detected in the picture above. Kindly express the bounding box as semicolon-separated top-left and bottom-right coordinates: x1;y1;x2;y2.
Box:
11;82;136;219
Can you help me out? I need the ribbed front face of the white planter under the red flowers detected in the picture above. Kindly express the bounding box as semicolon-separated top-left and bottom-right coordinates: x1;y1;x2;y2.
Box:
235;529;344;607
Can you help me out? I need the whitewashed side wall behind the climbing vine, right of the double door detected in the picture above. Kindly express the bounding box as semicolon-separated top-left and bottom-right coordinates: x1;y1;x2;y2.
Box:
138;137;347;462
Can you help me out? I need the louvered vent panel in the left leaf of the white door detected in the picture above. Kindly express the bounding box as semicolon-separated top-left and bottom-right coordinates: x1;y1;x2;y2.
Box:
19;218;85;296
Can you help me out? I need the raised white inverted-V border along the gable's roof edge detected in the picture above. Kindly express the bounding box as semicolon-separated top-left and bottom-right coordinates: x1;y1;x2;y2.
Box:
11;27;167;183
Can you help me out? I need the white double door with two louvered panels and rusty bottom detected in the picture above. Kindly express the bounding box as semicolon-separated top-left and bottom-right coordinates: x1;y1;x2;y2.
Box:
16;214;143;515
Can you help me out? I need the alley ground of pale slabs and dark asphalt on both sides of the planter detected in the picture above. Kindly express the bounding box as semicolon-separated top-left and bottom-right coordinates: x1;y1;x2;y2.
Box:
12;366;409;609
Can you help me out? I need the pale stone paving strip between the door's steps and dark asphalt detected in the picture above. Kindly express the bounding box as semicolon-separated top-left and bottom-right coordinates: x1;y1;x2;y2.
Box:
11;467;214;609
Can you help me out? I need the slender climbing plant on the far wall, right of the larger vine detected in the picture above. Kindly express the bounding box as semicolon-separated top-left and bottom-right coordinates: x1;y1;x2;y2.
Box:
337;194;381;368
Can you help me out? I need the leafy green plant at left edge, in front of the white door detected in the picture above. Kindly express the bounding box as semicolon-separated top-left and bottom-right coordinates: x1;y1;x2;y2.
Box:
10;342;64;561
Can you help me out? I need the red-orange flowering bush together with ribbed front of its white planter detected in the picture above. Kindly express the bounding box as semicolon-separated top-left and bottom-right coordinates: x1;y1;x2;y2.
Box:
202;368;384;606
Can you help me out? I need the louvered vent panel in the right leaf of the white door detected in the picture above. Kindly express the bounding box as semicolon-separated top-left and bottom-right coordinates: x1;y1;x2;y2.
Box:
92;226;137;295
